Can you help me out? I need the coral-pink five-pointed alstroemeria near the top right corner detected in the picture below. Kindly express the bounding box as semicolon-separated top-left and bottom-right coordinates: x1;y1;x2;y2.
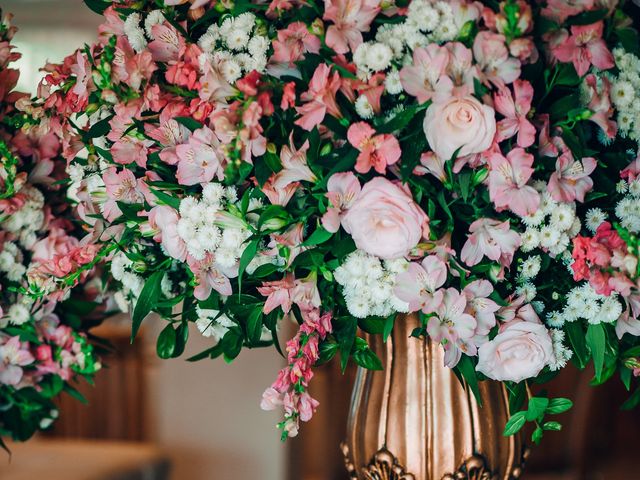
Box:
552;21;616;77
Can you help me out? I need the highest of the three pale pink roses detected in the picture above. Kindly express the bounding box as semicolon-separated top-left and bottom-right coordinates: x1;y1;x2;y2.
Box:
424;95;496;160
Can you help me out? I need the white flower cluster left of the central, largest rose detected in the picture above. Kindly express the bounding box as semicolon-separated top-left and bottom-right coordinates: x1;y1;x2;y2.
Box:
177;182;251;268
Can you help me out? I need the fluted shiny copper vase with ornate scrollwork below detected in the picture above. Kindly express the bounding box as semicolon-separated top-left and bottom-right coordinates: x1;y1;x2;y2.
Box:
343;315;522;480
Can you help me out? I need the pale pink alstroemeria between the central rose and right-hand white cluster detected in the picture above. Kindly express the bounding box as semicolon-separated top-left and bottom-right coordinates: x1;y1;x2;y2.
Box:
460;218;521;267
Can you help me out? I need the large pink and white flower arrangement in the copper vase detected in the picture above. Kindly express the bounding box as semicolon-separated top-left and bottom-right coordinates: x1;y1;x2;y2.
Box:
32;0;640;442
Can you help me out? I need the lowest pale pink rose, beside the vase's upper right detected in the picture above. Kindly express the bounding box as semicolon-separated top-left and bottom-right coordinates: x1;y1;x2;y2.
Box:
476;320;554;382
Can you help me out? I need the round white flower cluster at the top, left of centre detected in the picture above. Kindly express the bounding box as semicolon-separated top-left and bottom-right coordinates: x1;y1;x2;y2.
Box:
198;12;271;84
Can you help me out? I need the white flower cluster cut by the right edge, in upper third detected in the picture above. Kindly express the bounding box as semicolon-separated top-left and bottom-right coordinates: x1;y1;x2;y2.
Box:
611;48;640;141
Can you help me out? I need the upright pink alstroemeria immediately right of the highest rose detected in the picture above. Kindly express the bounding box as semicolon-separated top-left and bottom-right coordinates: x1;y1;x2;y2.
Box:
493;80;536;148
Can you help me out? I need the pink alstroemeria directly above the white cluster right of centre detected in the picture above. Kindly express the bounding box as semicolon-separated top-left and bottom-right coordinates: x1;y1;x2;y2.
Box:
547;151;598;202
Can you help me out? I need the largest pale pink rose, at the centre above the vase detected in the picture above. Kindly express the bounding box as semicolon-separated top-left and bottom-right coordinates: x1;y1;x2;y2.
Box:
342;177;429;259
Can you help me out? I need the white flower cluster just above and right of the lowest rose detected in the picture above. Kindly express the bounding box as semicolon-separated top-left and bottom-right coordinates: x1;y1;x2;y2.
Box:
547;283;622;328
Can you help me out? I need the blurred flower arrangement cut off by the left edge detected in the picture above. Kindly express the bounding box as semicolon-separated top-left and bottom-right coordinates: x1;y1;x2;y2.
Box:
0;11;102;448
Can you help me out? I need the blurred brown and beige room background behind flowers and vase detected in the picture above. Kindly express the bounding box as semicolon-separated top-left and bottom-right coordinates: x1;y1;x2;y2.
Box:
0;0;640;480
